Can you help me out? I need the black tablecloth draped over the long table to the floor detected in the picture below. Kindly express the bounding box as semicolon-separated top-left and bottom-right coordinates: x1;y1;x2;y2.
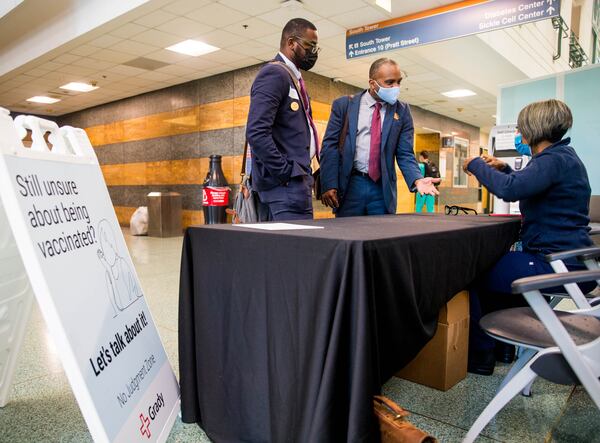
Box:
179;214;519;443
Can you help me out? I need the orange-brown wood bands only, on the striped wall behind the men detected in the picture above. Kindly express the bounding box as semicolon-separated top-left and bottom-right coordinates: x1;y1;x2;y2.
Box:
94;100;332;227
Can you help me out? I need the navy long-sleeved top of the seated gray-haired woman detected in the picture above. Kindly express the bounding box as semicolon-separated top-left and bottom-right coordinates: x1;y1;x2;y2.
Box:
467;138;592;254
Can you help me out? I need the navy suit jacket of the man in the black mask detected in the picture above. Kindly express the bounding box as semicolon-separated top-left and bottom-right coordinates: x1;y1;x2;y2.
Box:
246;55;311;191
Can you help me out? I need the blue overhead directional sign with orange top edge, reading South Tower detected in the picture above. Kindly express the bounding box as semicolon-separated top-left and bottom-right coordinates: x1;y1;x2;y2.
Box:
346;0;560;59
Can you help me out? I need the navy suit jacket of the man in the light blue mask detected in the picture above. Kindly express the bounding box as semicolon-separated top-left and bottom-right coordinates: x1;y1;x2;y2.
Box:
321;91;423;214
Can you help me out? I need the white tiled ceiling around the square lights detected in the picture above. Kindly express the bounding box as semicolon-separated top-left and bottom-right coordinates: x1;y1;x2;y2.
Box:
0;0;524;127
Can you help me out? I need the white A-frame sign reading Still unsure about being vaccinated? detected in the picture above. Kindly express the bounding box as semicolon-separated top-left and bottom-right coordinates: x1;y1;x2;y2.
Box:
0;108;179;442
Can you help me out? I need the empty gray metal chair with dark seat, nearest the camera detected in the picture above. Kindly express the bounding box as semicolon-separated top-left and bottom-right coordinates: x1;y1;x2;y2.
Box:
463;269;600;443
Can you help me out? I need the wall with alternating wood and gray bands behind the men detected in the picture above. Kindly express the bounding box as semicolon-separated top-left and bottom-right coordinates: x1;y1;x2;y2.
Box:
58;65;476;227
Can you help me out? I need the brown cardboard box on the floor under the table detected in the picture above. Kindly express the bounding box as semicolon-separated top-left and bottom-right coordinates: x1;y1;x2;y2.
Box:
396;291;469;391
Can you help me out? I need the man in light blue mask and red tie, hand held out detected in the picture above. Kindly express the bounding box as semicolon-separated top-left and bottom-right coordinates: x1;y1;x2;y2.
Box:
321;58;440;217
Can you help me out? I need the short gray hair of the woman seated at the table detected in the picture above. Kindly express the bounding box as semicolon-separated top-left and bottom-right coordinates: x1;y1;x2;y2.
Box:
517;99;573;147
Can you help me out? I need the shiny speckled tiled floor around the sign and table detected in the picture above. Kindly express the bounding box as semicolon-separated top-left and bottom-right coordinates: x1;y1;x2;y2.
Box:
0;230;600;443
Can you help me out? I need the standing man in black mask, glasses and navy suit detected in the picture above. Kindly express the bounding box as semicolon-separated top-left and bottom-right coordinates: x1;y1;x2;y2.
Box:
246;18;320;220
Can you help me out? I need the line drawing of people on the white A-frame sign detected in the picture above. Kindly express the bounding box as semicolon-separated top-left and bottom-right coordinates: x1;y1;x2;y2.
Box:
98;220;143;317
